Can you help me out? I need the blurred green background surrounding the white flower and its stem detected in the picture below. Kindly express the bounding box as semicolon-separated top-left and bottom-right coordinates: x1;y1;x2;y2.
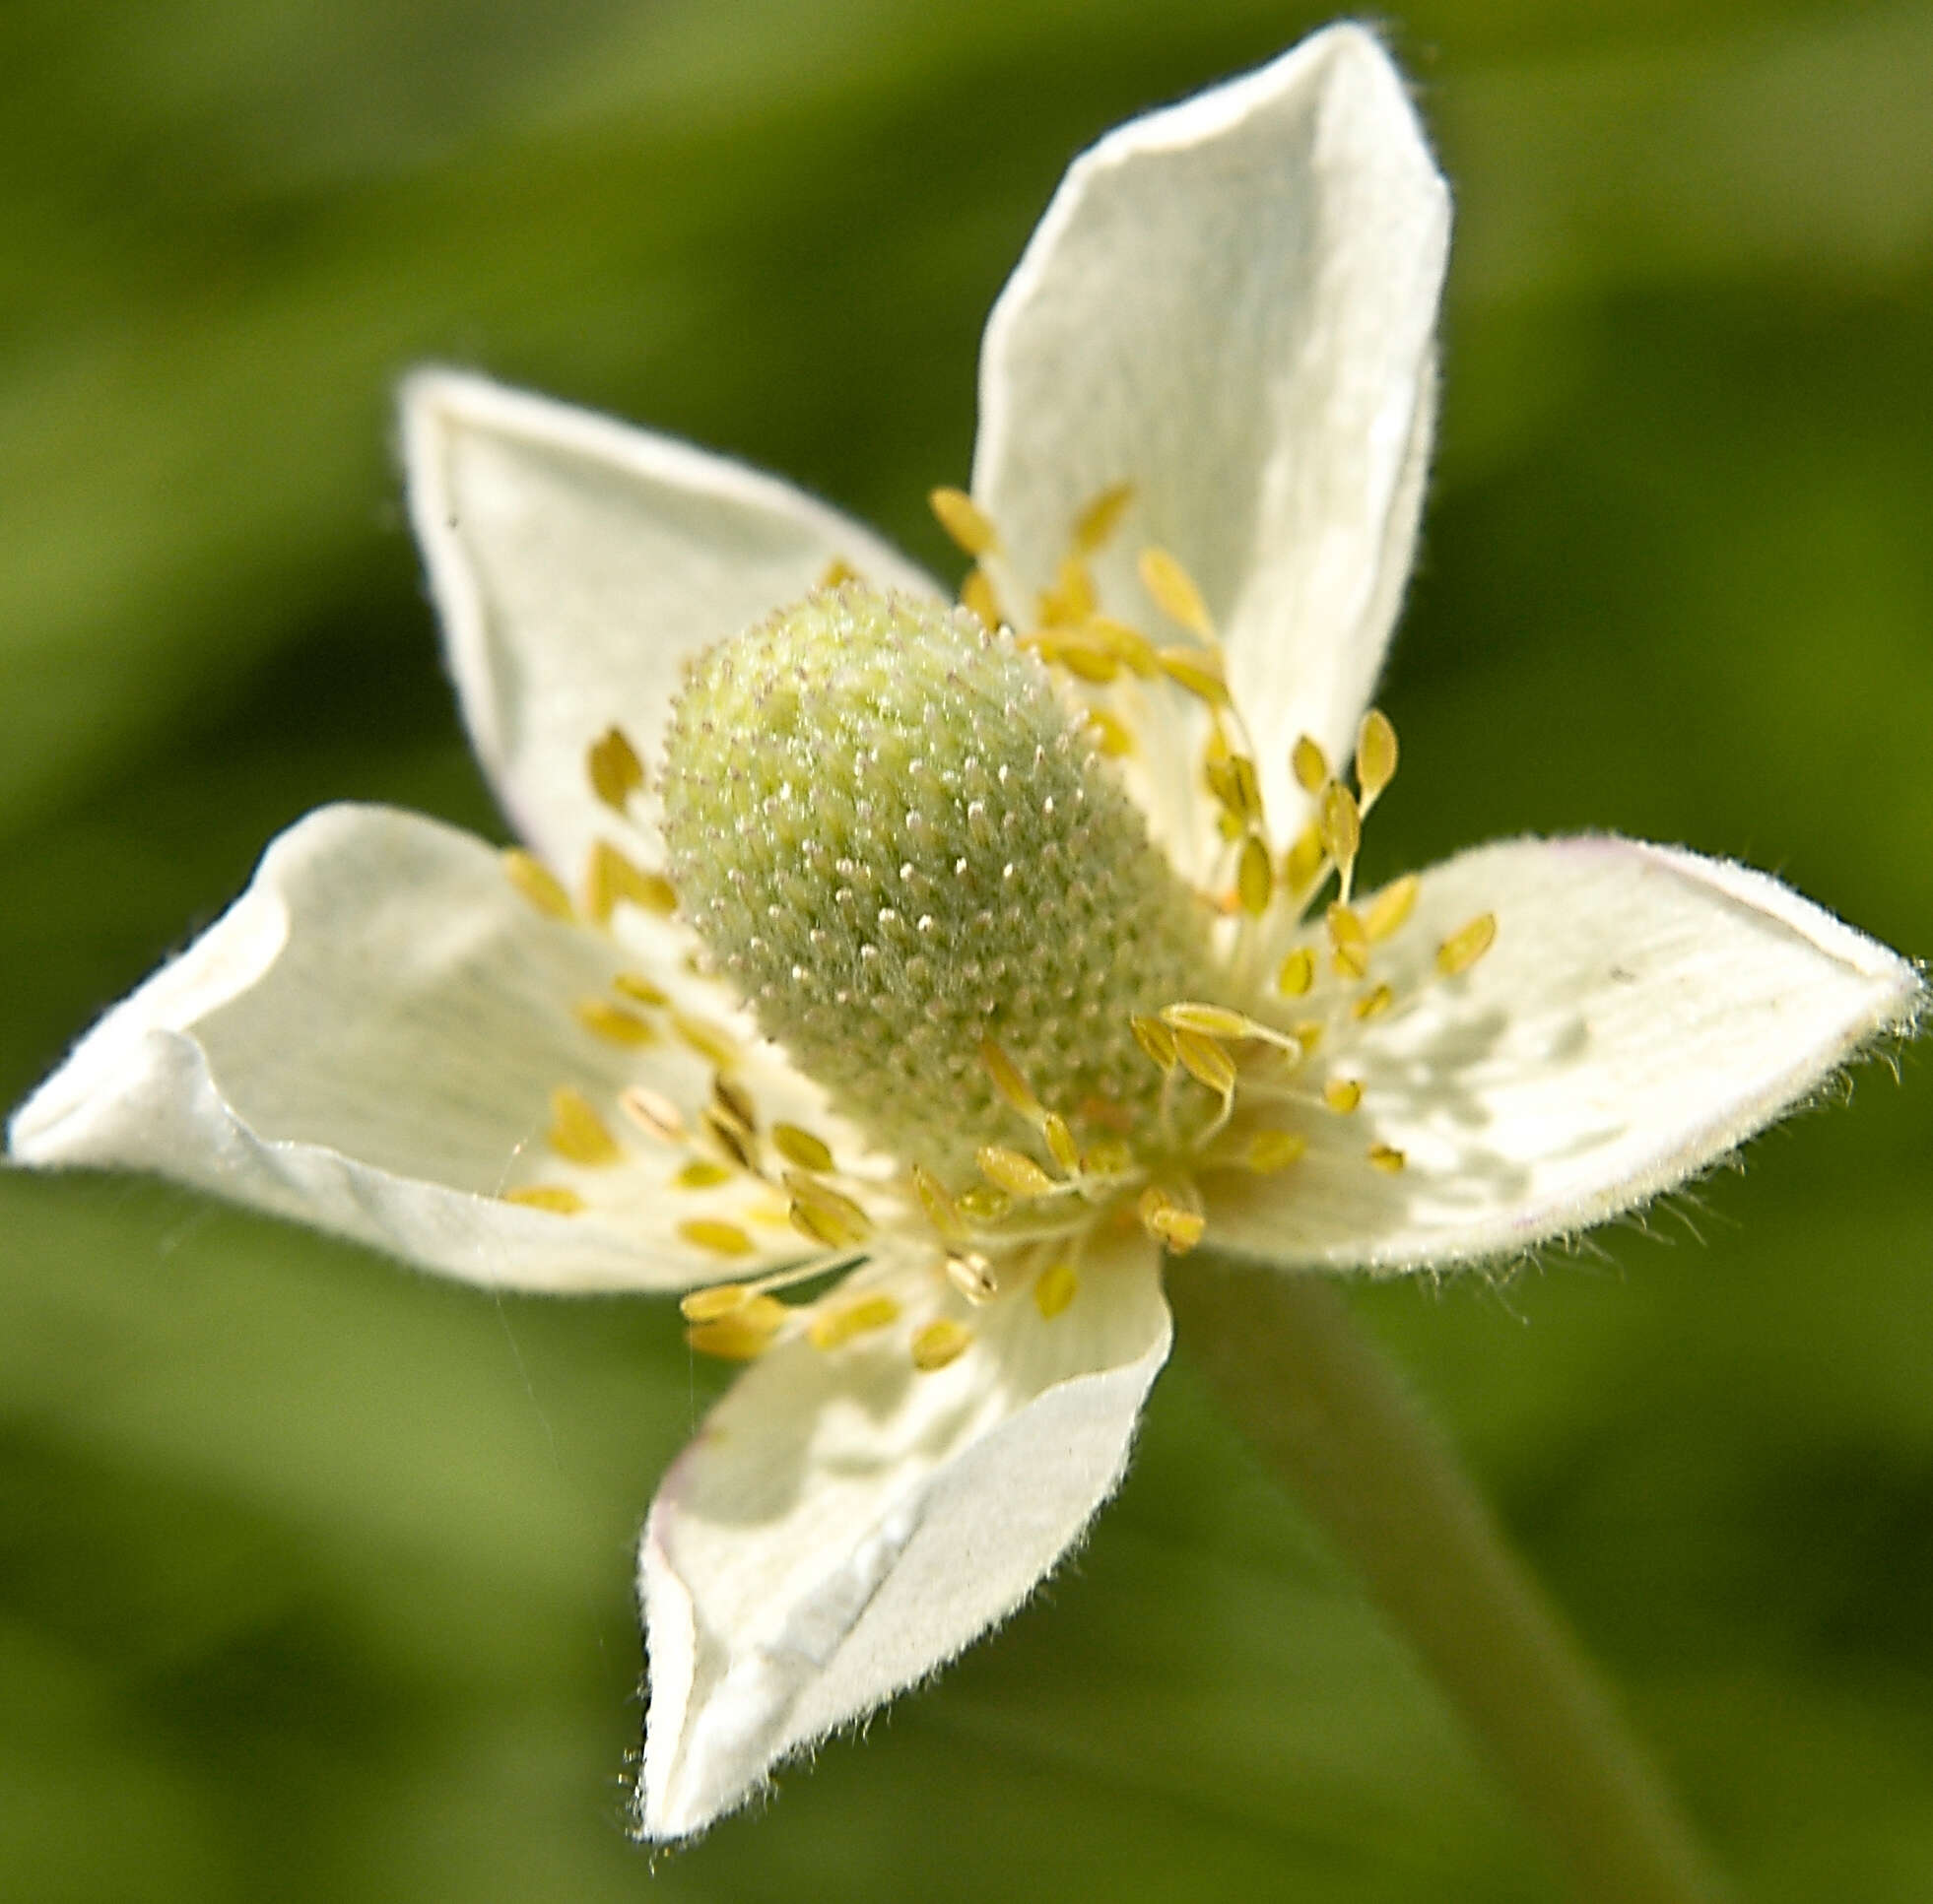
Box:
0;0;1933;1904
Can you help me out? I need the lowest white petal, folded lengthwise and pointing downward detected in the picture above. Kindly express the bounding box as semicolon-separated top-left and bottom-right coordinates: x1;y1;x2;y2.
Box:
637;1249;1169;1838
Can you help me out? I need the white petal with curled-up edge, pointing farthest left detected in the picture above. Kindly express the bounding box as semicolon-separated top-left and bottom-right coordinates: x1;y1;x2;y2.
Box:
8;806;862;1289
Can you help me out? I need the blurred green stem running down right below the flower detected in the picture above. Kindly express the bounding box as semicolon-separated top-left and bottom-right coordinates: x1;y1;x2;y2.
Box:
1167;1253;1720;1904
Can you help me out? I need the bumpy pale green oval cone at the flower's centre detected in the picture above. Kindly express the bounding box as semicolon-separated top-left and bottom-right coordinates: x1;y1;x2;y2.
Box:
663;584;1210;1175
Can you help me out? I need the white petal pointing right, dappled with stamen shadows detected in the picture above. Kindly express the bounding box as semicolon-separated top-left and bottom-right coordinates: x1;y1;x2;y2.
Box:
1210;837;1925;1270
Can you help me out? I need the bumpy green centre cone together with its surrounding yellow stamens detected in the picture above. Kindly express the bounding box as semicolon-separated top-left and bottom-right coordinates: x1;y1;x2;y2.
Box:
483;471;1497;1370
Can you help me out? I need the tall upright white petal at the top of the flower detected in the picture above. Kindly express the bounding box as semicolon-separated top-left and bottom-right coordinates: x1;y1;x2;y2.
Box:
974;26;1450;846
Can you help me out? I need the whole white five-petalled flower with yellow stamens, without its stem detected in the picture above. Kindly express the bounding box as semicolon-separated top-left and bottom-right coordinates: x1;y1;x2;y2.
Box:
10;27;1921;1838
